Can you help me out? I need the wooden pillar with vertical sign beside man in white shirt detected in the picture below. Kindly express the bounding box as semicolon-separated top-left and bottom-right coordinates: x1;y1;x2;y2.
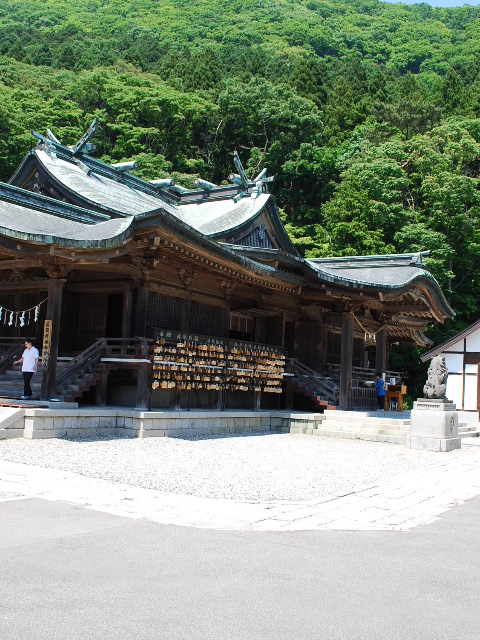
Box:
40;280;65;400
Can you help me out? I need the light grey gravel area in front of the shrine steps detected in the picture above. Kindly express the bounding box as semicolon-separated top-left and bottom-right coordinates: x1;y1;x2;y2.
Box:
0;434;480;502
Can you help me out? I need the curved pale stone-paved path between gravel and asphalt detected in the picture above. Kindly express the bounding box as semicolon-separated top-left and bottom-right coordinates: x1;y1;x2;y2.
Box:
0;438;480;531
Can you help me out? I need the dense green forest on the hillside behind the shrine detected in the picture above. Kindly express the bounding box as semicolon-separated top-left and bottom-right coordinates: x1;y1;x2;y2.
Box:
0;0;480;380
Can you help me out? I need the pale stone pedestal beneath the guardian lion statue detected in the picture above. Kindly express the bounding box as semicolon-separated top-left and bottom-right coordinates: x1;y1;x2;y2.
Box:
405;398;461;451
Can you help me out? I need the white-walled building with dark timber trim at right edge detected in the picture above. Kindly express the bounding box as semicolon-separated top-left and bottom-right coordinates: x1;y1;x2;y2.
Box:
421;320;480;411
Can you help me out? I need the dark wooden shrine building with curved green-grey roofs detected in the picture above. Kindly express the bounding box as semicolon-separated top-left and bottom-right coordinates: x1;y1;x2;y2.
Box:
0;121;453;411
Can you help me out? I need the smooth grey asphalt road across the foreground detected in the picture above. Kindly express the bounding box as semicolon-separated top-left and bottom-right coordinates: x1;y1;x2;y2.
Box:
0;498;480;640
